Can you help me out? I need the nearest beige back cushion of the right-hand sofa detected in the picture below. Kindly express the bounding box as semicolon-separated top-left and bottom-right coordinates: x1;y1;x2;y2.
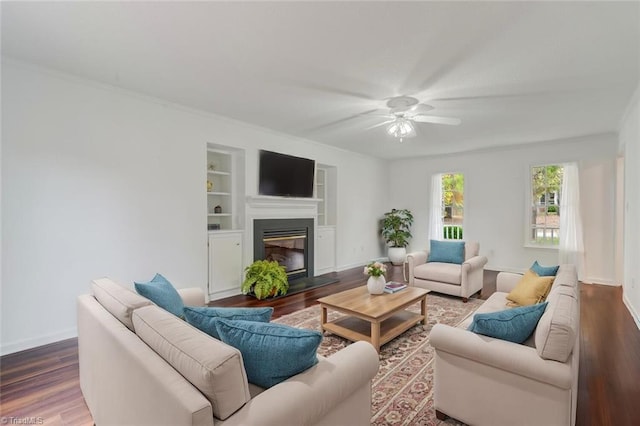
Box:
535;286;580;362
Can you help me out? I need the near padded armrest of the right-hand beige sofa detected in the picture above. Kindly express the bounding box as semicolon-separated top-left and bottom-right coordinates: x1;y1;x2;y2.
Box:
429;324;573;389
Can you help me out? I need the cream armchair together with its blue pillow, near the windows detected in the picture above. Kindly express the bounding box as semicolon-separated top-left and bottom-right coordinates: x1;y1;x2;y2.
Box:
407;240;487;303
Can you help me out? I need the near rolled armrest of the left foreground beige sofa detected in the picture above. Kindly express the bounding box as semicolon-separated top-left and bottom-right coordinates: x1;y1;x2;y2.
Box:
224;342;379;426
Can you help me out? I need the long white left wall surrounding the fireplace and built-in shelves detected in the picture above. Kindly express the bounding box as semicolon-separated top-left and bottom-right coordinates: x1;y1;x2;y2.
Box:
0;60;387;354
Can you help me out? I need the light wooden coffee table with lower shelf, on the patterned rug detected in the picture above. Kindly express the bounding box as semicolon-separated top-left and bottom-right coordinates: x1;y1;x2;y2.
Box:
318;286;429;352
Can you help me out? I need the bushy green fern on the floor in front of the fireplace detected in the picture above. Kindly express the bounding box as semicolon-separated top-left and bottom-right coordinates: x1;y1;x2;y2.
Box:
241;260;289;299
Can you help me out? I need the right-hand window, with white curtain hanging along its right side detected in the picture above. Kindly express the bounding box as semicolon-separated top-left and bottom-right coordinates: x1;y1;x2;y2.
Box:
527;164;564;246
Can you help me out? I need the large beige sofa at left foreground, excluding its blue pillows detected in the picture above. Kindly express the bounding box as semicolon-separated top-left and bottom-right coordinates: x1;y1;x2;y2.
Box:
77;278;378;426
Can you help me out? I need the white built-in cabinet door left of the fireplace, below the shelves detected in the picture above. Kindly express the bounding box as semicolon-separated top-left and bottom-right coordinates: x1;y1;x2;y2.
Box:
209;232;242;294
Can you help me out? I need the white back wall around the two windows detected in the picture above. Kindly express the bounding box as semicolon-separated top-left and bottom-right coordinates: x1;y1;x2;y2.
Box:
391;135;617;284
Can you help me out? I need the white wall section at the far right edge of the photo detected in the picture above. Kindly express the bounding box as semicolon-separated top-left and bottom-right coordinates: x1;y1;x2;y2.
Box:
620;85;640;328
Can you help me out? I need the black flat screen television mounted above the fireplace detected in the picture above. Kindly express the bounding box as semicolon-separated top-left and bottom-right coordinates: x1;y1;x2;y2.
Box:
258;150;316;198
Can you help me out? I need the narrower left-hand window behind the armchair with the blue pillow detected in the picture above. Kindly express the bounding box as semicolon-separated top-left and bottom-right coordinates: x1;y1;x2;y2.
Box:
442;173;464;240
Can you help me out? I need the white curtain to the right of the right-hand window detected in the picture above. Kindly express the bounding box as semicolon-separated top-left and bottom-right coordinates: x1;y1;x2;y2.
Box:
558;163;584;279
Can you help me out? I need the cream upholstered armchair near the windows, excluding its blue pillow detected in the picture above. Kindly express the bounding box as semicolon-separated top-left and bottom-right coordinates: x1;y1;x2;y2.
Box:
407;241;487;303
